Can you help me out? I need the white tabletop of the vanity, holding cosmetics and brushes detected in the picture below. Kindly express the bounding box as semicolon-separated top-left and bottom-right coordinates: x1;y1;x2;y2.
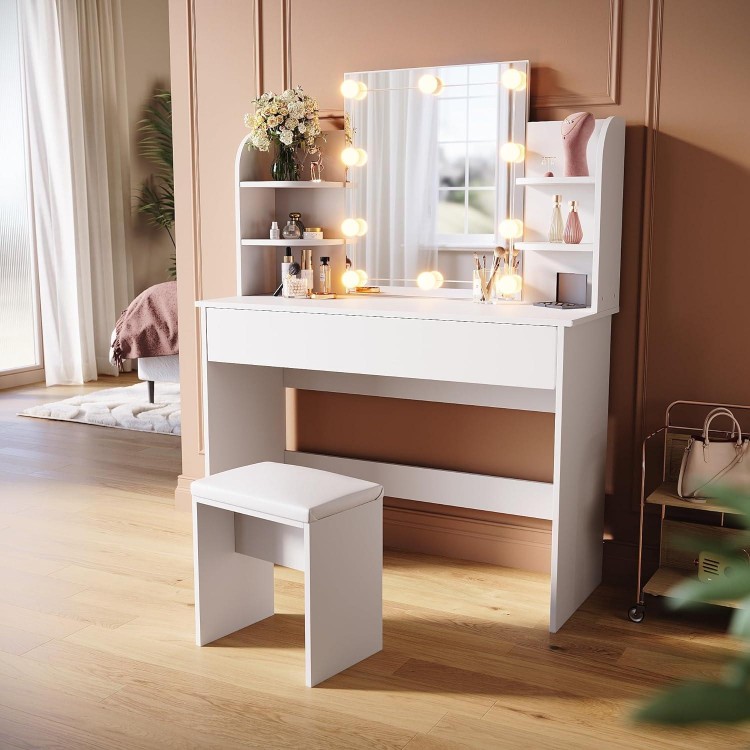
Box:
196;294;617;327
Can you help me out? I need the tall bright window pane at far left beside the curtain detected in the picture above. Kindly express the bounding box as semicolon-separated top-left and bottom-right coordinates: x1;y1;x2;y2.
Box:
0;0;40;372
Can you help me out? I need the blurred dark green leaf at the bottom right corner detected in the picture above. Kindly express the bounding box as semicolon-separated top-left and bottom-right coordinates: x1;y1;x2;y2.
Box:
635;682;750;724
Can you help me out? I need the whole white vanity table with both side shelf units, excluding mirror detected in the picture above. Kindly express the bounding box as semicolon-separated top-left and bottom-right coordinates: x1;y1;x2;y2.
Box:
197;88;625;632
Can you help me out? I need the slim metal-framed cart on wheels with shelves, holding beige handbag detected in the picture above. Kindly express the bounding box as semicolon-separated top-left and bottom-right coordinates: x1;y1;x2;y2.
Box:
628;401;750;622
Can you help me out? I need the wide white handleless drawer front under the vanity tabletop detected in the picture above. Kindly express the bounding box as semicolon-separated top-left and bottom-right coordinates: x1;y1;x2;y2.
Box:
205;307;557;389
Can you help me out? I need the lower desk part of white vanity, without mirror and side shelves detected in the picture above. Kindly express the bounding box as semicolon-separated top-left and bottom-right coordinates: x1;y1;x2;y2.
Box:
199;296;615;632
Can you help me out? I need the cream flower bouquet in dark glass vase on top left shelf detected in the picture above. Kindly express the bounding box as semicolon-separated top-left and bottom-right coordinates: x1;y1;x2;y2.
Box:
245;86;325;180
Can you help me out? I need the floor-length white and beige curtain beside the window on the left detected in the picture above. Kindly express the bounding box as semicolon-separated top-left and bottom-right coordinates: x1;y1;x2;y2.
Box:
18;0;133;385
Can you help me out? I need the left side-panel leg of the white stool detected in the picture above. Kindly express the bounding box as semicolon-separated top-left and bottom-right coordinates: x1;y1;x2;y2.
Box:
193;499;273;646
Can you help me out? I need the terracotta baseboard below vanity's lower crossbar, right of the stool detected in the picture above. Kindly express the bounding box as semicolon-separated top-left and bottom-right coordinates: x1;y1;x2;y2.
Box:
383;498;552;573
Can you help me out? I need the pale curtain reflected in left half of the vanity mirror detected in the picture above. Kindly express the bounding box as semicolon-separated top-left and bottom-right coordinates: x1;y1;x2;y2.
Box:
348;70;438;286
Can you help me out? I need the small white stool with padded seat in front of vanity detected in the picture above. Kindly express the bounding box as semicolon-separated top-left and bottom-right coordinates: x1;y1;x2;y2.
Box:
191;463;383;687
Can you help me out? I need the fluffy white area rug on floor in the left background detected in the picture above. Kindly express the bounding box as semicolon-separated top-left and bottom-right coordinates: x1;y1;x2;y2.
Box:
20;381;181;435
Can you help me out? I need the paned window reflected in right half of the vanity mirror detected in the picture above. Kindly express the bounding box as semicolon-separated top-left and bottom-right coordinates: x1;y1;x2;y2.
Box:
436;65;498;247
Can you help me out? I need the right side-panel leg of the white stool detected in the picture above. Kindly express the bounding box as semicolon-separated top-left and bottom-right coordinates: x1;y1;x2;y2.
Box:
305;498;383;687
